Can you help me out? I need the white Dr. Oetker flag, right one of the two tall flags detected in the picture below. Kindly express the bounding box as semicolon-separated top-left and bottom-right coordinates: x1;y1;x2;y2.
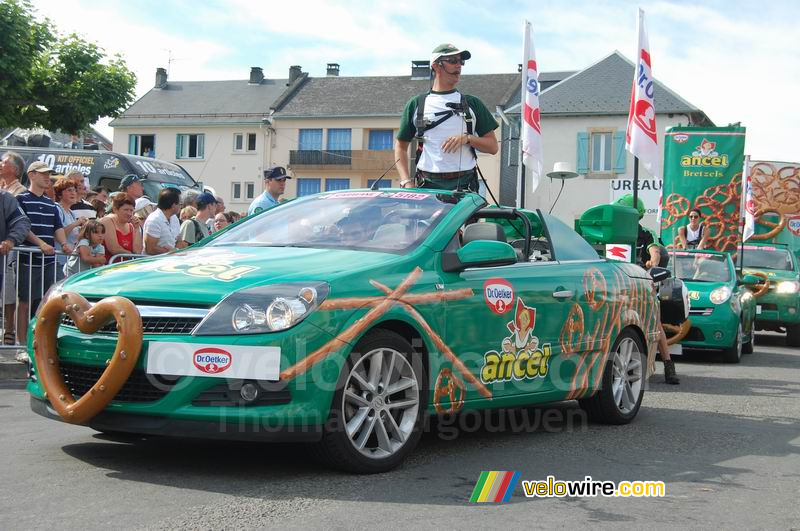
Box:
625;9;661;178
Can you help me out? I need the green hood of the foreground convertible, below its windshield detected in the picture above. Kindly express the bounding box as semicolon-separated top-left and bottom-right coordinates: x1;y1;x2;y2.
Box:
63;247;405;305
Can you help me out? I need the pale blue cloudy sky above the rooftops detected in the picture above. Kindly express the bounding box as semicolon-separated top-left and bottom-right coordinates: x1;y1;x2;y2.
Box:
33;0;800;161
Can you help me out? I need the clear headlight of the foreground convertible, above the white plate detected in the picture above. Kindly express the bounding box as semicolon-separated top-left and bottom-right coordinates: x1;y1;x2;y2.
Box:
194;282;329;336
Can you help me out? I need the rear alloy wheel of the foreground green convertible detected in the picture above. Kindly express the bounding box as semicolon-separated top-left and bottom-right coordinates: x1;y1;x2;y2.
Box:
578;329;646;424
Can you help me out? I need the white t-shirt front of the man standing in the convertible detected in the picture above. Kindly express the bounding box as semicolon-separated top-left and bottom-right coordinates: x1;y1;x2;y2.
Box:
417;90;476;173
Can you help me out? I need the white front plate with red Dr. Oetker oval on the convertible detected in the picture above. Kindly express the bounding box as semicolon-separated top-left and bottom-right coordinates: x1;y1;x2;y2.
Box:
146;341;281;381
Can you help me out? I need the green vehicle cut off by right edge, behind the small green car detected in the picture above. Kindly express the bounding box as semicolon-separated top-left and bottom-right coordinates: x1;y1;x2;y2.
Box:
740;243;800;347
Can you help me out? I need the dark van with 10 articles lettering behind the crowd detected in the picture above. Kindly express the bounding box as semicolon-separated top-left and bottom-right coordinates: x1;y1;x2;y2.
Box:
0;146;202;200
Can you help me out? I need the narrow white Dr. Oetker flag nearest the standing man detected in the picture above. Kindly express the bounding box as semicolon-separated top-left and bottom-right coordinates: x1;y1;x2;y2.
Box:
522;20;544;192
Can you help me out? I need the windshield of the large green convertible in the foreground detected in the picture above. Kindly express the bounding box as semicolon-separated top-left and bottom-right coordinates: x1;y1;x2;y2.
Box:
209;190;454;253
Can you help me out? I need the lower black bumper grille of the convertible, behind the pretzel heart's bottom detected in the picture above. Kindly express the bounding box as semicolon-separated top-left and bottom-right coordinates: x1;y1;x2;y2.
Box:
59;360;179;403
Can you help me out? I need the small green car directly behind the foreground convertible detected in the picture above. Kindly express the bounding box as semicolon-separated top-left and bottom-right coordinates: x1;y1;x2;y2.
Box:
669;250;758;363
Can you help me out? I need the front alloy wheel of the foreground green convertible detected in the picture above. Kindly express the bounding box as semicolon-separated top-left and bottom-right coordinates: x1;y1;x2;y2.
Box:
316;330;427;474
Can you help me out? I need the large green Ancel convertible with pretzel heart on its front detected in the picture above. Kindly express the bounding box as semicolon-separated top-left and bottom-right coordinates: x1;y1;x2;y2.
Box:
28;189;659;472
